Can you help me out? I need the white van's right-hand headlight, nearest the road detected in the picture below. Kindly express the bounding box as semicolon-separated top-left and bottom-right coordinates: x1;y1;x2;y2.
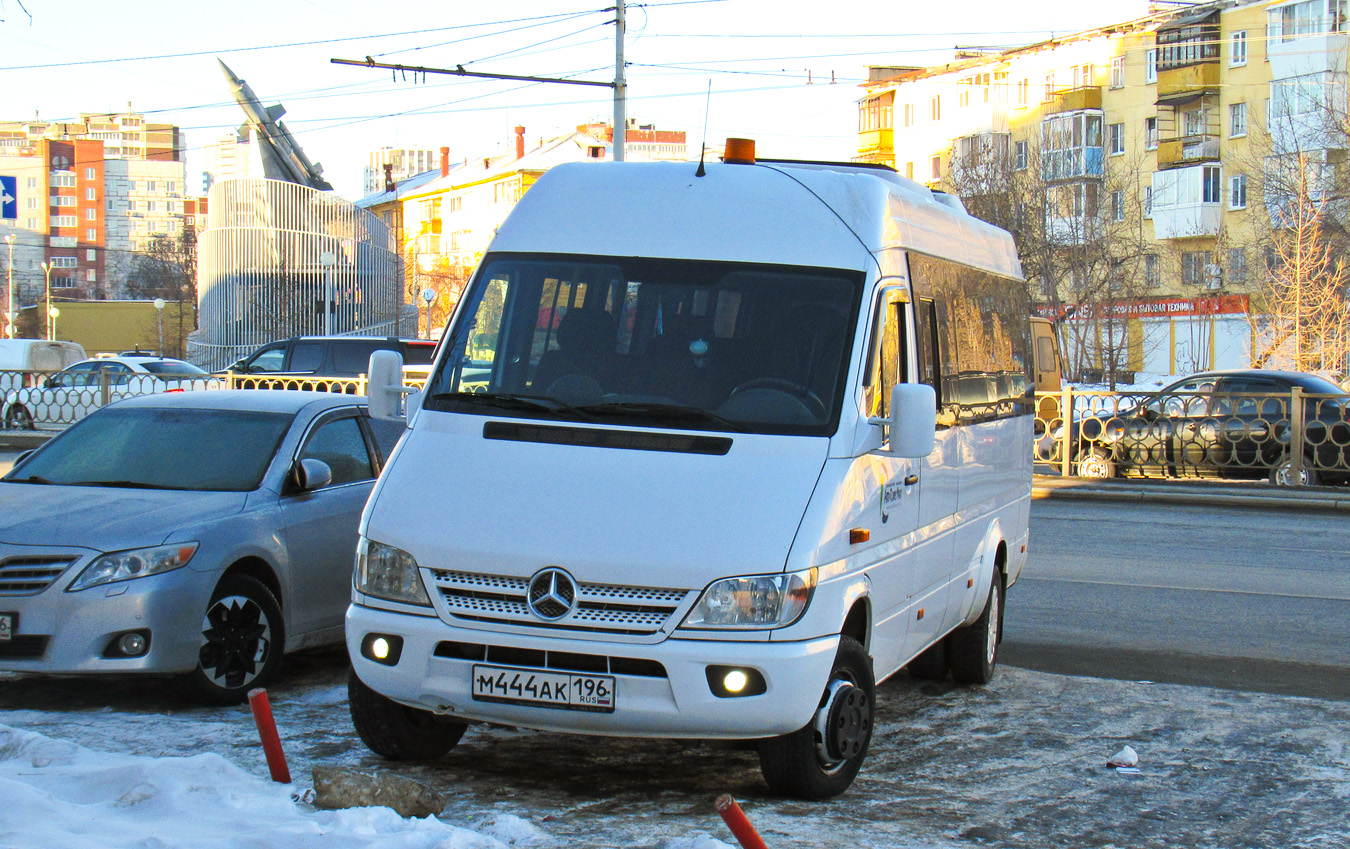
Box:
682;568;815;629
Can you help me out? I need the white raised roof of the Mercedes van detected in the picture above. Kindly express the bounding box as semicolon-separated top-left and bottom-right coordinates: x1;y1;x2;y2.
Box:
493;161;1022;278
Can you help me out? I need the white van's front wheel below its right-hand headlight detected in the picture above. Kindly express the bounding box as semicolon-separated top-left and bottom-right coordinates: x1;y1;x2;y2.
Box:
759;637;876;802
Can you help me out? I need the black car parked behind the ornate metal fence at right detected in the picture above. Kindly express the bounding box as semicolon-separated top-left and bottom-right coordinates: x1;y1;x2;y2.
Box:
1038;370;1350;485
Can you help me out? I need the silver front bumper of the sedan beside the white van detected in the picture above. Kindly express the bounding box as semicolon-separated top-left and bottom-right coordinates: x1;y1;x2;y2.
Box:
0;559;213;672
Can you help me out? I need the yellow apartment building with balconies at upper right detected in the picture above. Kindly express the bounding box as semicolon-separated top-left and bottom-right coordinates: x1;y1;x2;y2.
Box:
856;0;1347;374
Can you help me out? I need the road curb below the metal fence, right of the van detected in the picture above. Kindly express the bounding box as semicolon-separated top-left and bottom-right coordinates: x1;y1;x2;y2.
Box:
1031;478;1350;513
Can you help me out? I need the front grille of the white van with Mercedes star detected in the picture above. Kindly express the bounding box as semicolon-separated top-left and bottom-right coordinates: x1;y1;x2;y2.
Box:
432;570;693;634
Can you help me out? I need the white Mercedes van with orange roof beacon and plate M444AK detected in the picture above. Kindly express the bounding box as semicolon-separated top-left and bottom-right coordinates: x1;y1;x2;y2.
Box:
347;143;1033;799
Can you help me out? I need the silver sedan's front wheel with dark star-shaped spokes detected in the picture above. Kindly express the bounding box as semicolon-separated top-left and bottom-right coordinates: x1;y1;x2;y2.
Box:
189;575;285;705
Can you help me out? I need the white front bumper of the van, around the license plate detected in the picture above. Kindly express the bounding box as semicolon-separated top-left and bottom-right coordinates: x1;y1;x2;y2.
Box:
347;605;838;740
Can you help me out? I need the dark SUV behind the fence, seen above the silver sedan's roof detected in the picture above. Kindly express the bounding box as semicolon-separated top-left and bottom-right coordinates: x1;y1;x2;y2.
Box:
230;336;436;378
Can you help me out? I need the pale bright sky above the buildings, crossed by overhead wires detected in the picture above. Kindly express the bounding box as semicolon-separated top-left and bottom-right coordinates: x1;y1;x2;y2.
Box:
0;0;1146;198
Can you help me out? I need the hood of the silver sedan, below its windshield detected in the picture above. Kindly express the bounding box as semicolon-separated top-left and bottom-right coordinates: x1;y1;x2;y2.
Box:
0;482;248;551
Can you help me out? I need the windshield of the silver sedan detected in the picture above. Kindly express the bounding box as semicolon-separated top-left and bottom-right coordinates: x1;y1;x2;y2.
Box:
0;408;294;493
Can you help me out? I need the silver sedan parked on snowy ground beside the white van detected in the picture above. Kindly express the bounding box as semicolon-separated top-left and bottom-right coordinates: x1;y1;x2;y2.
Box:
0;390;401;703
